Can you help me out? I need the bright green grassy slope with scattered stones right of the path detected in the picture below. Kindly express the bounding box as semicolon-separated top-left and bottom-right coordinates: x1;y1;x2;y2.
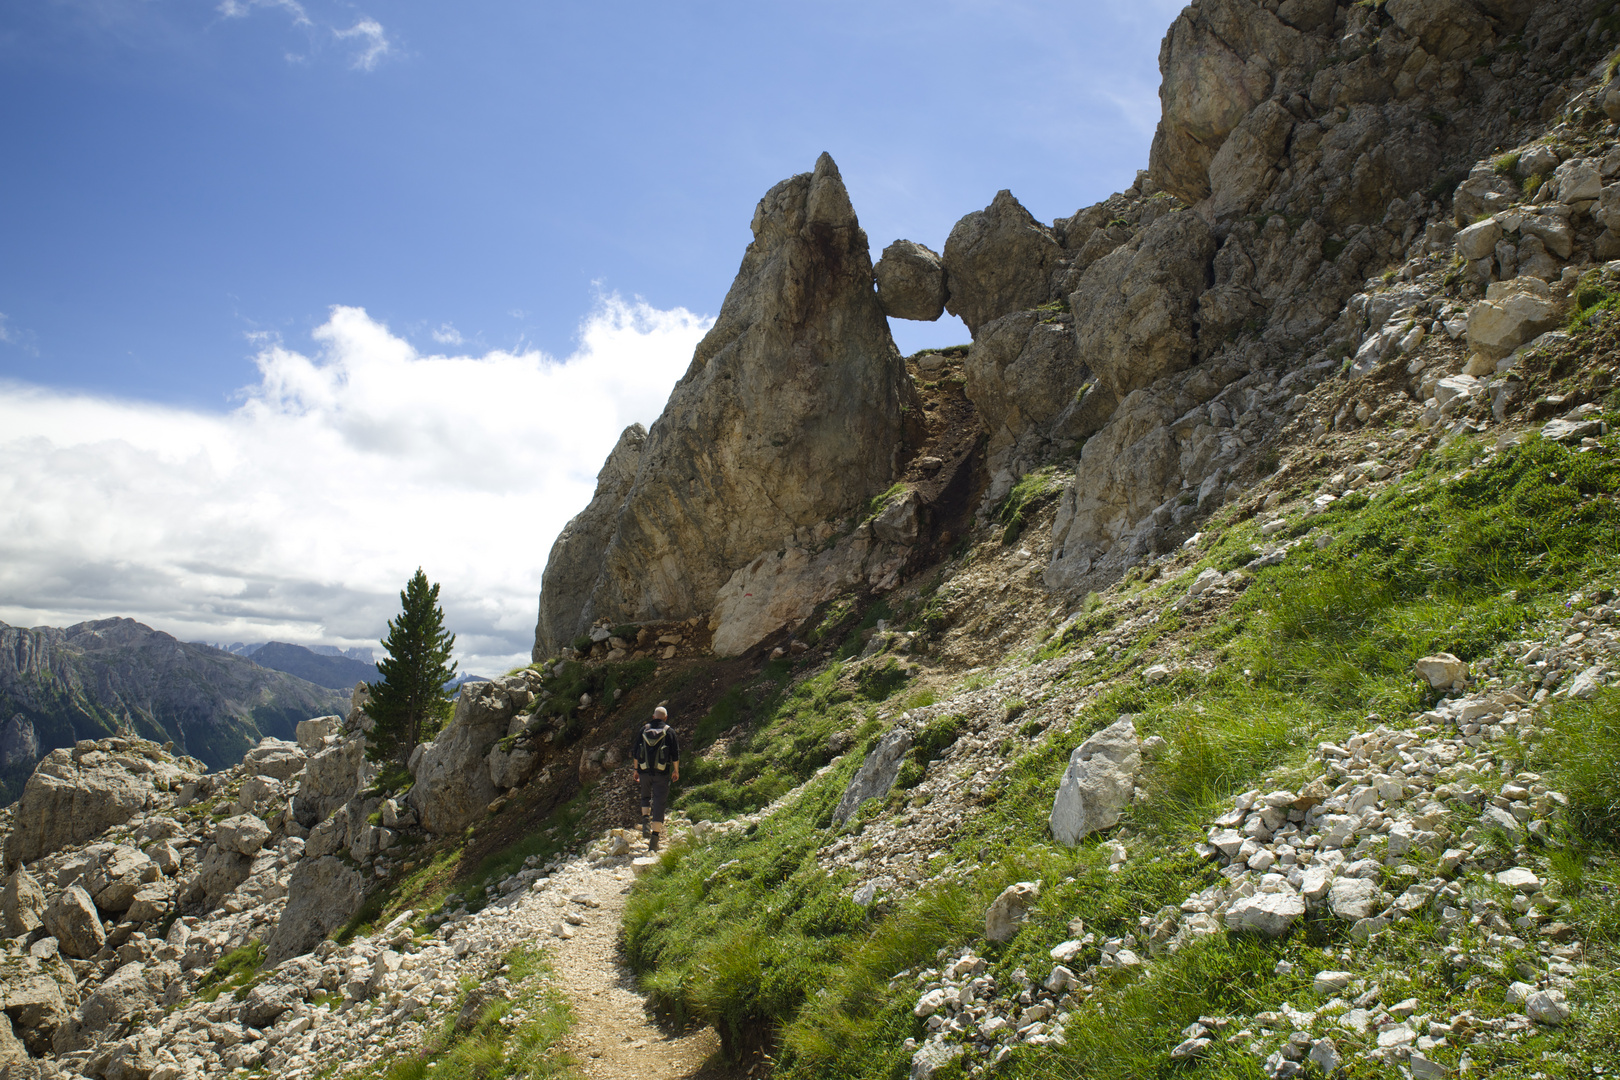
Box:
625;424;1620;1078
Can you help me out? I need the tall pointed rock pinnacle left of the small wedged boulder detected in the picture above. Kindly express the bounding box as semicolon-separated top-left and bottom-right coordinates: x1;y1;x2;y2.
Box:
535;154;910;656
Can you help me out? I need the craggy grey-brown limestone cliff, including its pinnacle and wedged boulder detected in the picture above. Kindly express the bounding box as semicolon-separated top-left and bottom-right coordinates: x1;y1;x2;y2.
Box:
536;0;1620;657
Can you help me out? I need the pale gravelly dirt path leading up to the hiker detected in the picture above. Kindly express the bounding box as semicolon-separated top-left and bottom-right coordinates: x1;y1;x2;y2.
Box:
537;834;739;1080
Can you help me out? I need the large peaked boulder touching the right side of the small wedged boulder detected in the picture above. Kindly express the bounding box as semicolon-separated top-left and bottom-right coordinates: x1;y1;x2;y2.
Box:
941;191;1063;338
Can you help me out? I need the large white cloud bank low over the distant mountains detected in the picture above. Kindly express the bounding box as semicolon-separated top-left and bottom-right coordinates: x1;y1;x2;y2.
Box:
0;296;710;674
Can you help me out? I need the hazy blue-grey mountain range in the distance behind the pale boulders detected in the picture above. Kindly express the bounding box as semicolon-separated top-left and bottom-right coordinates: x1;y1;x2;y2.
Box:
0;619;348;801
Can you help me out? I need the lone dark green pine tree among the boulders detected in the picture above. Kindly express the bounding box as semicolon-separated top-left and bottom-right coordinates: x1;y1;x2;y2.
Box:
366;567;455;769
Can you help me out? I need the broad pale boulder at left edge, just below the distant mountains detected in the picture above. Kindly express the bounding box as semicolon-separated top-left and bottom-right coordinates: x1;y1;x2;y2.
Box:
5;743;194;866
